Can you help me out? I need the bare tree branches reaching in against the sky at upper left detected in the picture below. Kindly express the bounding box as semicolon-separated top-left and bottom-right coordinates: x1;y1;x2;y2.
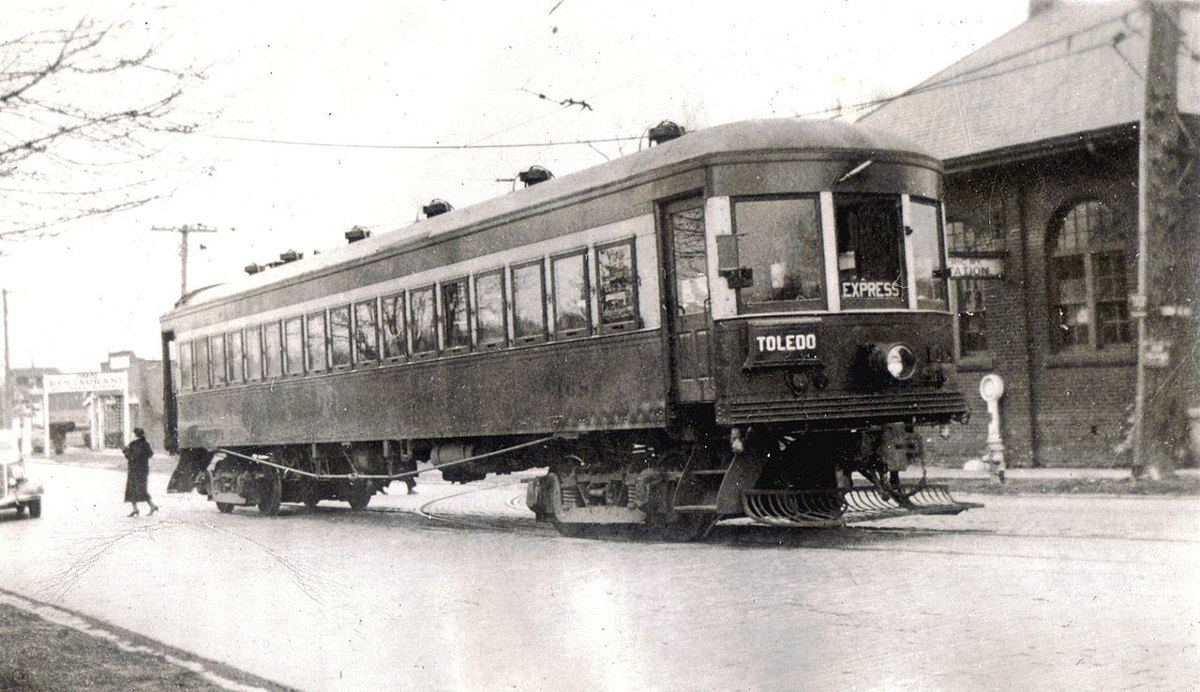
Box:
0;6;202;240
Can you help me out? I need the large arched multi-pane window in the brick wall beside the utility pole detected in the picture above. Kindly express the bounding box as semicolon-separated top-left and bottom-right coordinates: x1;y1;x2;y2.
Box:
1046;200;1133;350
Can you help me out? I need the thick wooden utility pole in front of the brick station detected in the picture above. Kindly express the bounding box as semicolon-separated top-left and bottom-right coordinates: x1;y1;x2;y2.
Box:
1132;0;1200;479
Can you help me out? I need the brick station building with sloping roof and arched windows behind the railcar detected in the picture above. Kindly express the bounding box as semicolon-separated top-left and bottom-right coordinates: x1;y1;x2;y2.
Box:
860;0;1200;465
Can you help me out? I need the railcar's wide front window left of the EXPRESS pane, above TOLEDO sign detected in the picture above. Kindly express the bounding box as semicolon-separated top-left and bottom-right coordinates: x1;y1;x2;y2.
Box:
733;198;824;309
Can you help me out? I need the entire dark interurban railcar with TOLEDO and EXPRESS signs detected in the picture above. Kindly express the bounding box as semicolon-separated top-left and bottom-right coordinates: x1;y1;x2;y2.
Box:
162;120;968;537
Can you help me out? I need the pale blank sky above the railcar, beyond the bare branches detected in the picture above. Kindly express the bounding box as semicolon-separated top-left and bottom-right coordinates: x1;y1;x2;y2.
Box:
0;0;1028;372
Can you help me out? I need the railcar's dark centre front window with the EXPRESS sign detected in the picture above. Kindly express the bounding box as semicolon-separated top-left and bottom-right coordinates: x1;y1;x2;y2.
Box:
834;194;907;309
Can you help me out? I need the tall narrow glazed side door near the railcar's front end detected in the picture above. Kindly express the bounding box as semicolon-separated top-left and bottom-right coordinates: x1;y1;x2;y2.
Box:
660;197;716;403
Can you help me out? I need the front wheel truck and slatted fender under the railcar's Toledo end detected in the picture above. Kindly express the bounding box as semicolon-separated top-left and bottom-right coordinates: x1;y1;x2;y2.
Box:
527;426;979;540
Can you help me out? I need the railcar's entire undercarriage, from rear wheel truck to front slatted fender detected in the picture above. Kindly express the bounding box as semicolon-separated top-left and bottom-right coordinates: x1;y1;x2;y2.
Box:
181;425;979;541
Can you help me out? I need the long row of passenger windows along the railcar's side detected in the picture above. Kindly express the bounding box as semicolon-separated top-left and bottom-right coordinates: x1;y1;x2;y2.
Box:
176;239;640;391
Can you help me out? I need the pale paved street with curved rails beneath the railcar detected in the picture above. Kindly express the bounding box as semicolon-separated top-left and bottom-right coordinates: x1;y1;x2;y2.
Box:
0;455;1200;691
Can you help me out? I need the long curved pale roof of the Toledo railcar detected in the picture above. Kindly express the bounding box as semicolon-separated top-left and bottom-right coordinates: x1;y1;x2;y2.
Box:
166;119;932;309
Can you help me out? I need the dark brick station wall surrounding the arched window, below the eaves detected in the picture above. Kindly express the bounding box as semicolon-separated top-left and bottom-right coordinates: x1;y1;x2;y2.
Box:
929;138;1138;467
